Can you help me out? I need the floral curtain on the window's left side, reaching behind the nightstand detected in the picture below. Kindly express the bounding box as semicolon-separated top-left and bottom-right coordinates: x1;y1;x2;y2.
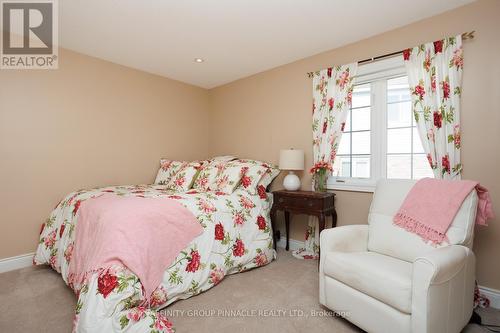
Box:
293;63;358;259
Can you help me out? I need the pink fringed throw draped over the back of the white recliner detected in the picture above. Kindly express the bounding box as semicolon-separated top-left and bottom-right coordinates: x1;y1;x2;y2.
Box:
393;178;494;244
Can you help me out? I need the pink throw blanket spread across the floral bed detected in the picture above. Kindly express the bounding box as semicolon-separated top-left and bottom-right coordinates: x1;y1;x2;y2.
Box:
69;194;203;300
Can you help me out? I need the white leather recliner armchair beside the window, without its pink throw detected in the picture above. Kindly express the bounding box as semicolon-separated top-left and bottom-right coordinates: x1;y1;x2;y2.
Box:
319;180;478;333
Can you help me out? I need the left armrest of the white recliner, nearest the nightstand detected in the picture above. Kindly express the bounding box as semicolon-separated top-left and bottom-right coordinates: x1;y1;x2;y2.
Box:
320;224;368;253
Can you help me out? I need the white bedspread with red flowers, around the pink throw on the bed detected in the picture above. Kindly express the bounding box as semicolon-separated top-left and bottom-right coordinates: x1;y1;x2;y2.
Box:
33;185;276;333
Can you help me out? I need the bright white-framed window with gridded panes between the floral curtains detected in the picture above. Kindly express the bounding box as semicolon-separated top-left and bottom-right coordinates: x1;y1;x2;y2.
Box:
328;57;433;191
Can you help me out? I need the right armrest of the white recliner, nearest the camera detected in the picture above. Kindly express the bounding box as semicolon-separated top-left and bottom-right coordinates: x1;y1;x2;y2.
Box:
411;245;476;333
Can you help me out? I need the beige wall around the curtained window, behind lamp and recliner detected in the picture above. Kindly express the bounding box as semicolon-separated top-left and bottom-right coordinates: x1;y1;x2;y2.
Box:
210;0;500;289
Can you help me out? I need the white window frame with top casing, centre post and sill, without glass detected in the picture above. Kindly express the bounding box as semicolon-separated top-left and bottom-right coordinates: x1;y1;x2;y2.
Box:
327;56;407;192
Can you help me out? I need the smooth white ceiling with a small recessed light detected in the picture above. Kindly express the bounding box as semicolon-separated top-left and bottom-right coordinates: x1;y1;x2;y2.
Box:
59;0;473;88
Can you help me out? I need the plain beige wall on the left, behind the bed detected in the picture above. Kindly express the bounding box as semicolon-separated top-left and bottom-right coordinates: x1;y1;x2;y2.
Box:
0;50;209;258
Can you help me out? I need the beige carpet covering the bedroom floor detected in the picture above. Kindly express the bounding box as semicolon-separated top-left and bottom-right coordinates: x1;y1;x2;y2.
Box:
0;251;500;333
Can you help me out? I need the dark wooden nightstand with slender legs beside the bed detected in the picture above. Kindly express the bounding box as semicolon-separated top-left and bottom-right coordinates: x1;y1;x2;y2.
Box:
271;191;337;251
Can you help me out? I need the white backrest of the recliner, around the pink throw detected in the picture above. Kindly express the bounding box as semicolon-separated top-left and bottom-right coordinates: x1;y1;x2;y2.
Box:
368;179;478;262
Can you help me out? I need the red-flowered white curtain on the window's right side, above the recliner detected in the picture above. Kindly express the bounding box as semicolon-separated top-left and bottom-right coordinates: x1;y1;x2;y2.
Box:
403;35;463;179
